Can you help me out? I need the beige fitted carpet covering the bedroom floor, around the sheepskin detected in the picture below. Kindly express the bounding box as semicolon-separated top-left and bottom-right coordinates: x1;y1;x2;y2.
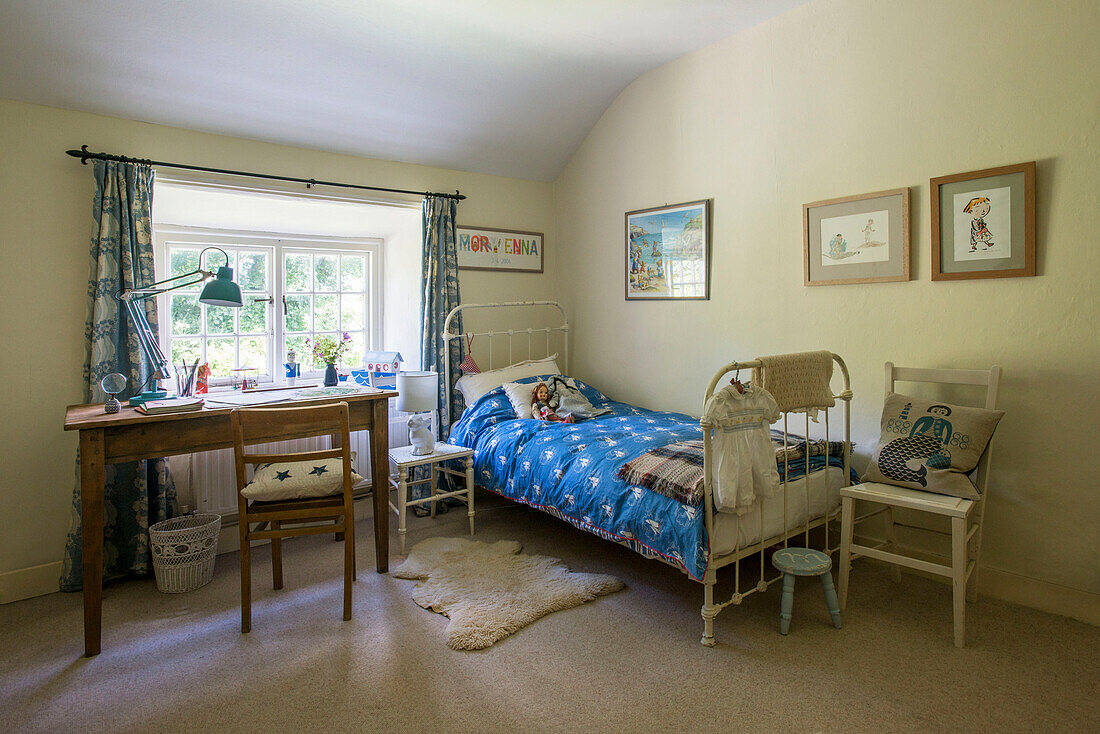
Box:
0;495;1100;734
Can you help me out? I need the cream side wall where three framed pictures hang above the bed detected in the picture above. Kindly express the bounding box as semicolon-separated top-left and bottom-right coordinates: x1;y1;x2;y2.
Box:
553;0;1100;621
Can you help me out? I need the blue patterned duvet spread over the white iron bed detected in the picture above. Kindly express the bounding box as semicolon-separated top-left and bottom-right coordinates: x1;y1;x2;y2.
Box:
449;377;840;581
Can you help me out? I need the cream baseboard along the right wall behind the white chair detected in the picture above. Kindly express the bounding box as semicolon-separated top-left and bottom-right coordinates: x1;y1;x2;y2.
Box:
855;536;1100;626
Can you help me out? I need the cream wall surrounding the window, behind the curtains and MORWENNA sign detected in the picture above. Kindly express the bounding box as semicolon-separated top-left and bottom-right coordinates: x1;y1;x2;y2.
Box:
0;100;559;602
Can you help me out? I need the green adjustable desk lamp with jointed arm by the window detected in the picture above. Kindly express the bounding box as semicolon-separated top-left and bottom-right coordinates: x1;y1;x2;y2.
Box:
114;248;244;406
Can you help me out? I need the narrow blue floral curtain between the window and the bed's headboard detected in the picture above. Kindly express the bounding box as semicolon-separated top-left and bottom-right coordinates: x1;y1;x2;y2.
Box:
420;196;463;440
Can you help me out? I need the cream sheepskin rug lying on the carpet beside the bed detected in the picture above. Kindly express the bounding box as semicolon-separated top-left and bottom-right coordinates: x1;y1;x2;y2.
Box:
393;538;623;650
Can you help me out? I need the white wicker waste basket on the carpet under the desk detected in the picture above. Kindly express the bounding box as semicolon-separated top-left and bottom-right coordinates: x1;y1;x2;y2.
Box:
149;513;221;594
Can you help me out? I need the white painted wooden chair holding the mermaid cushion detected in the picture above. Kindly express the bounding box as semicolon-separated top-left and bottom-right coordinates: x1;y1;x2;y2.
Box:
839;362;1001;647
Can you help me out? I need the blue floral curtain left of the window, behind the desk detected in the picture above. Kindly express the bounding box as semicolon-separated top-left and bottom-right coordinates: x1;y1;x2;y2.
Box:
61;161;176;591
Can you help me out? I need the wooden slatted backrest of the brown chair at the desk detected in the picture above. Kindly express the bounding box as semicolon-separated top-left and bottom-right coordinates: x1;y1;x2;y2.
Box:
230;403;352;493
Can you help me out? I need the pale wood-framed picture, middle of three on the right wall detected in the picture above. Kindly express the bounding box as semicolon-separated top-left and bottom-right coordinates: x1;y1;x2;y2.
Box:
802;188;909;285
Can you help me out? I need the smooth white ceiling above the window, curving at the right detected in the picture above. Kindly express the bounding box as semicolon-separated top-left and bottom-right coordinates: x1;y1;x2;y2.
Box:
0;0;805;180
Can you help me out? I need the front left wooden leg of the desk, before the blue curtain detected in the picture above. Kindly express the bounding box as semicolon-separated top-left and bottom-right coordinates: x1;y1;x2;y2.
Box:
80;428;107;657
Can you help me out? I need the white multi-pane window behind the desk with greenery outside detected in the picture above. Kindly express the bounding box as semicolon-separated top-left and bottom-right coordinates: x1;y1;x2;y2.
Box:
156;228;382;386
